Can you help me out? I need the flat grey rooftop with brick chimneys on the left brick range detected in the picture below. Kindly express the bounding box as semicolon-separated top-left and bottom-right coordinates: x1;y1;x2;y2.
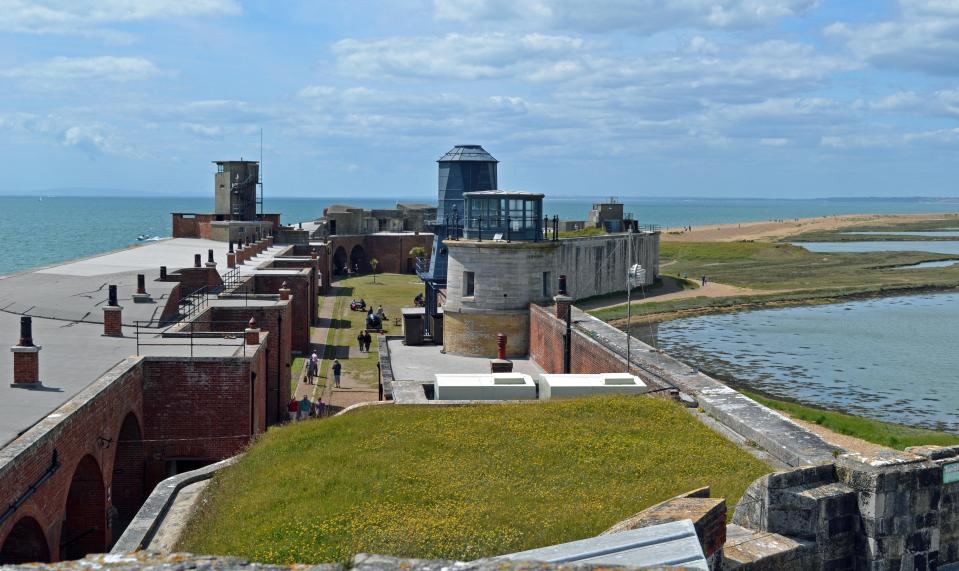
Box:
0;238;297;448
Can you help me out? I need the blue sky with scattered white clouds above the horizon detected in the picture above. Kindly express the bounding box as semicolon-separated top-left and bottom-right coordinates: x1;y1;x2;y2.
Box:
0;0;959;198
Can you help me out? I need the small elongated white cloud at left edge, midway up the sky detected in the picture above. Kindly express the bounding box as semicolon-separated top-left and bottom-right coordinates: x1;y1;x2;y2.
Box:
0;56;159;89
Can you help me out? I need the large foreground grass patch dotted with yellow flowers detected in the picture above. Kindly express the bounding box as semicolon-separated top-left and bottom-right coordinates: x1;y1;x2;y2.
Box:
177;397;770;563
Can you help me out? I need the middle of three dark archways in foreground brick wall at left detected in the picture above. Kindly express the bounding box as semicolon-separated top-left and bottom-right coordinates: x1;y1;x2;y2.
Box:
60;454;107;560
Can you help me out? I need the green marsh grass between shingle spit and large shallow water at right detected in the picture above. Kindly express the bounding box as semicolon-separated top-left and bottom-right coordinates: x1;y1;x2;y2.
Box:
591;242;959;321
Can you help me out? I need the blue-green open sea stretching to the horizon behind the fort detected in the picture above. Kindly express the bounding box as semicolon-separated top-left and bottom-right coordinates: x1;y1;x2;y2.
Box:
0;196;959;275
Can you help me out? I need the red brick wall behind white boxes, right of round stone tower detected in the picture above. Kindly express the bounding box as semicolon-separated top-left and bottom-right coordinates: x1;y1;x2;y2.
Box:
529;304;626;373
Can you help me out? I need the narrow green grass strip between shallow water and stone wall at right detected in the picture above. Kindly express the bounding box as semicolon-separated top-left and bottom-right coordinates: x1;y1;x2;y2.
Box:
742;391;959;450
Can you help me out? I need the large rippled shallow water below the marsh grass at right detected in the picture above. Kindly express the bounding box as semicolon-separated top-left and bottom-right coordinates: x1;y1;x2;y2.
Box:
633;293;959;432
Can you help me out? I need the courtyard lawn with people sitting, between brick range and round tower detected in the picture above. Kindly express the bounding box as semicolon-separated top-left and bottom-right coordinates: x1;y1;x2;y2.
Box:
321;274;423;386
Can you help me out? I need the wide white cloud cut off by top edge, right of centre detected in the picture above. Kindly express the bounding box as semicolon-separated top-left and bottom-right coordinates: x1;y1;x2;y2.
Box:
434;0;819;33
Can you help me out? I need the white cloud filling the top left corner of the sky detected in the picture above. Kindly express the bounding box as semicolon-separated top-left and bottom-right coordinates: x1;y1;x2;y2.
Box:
0;0;241;40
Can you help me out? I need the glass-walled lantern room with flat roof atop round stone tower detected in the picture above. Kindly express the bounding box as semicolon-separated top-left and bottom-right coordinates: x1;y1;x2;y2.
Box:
463;190;543;241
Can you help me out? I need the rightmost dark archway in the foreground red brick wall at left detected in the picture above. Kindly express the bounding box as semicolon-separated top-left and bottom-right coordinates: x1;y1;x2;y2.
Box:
110;412;146;545
